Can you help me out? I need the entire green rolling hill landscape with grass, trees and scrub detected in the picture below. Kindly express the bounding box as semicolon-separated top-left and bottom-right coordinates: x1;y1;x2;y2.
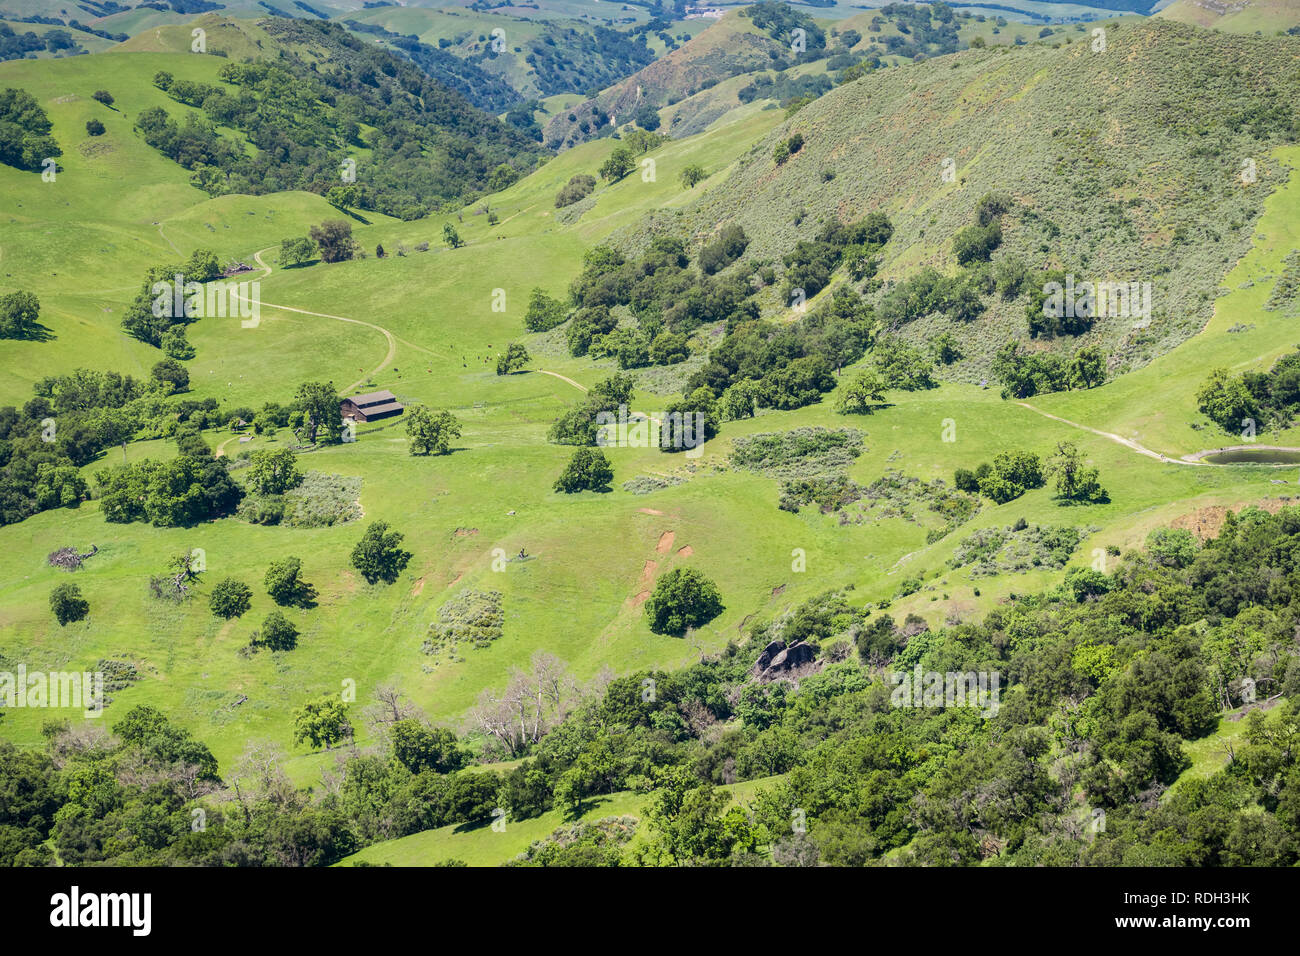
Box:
0;4;1300;866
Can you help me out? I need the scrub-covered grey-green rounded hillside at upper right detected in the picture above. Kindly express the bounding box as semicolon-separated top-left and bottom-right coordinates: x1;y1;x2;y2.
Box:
650;22;1300;382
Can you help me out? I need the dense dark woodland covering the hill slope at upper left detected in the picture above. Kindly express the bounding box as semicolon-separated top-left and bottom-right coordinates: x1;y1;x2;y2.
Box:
137;20;540;220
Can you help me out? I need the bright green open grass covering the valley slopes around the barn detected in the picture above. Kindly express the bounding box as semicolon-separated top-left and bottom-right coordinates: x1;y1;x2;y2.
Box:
0;22;1300;806
